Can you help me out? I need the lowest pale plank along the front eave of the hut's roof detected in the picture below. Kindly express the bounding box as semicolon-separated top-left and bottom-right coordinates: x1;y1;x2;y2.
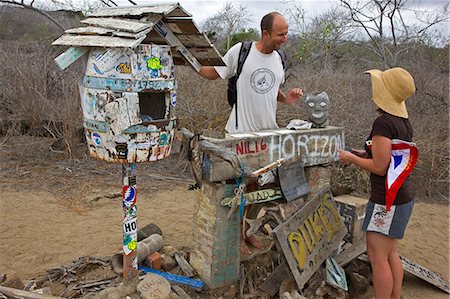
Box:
52;34;145;48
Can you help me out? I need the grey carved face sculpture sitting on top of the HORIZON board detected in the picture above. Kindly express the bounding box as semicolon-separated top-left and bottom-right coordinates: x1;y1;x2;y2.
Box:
305;91;330;128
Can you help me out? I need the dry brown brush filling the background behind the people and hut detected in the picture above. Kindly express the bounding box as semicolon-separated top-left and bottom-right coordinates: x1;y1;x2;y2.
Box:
0;1;449;200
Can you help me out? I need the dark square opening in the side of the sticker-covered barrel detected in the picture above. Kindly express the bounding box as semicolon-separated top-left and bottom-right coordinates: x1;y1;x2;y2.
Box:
139;92;167;123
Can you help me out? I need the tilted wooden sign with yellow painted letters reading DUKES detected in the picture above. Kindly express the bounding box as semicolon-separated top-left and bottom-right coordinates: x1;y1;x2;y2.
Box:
273;189;347;290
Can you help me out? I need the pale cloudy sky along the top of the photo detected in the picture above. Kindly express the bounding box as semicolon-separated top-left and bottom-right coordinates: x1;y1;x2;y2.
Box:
114;0;450;36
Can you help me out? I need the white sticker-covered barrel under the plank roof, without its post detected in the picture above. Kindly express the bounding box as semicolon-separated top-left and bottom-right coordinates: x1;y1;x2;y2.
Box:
80;44;177;163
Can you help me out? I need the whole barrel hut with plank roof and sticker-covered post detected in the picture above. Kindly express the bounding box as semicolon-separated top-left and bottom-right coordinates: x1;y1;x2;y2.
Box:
53;4;224;278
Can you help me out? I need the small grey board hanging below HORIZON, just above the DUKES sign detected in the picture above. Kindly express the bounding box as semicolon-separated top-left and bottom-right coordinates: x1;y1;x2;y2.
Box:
278;160;310;202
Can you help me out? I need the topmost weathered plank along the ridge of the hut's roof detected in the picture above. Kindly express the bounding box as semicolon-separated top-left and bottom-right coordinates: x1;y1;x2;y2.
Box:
87;4;192;17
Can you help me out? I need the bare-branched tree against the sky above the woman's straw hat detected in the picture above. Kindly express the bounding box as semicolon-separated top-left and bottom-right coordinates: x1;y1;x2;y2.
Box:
340;0;449;68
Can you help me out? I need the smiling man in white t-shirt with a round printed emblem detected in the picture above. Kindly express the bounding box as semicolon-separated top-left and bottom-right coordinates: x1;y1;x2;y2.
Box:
199;12;303;133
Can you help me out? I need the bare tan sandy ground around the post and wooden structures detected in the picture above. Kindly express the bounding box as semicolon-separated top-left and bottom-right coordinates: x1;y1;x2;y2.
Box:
0;141;449;299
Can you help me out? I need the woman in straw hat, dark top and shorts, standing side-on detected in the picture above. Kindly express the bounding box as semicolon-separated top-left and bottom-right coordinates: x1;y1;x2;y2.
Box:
339;68;418;299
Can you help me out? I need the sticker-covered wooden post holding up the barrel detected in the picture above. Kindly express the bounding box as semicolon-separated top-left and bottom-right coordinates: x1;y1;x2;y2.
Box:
122;163;138;280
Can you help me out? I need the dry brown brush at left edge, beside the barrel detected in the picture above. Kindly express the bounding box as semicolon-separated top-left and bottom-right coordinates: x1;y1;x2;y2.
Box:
0;42;82;152
